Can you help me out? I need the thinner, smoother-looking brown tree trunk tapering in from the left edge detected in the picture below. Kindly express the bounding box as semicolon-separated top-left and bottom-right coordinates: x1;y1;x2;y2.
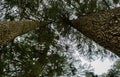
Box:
0;21;46;46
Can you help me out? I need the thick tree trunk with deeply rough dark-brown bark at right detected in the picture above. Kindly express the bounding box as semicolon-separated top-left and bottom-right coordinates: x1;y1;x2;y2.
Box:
72;8;120;57
